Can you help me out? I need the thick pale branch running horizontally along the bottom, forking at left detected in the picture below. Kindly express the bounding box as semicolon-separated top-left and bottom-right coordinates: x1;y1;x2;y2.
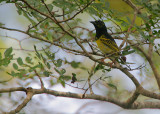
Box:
0;87;160;114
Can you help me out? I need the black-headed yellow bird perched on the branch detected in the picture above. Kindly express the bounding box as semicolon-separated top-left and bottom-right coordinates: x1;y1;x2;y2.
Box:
90;20;119;57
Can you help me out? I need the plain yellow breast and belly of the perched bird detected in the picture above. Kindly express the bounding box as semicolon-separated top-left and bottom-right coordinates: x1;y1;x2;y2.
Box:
96;39;113;54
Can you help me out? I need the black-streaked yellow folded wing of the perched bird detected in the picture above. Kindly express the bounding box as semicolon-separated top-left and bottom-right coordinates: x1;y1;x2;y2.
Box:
100;35;119;52
